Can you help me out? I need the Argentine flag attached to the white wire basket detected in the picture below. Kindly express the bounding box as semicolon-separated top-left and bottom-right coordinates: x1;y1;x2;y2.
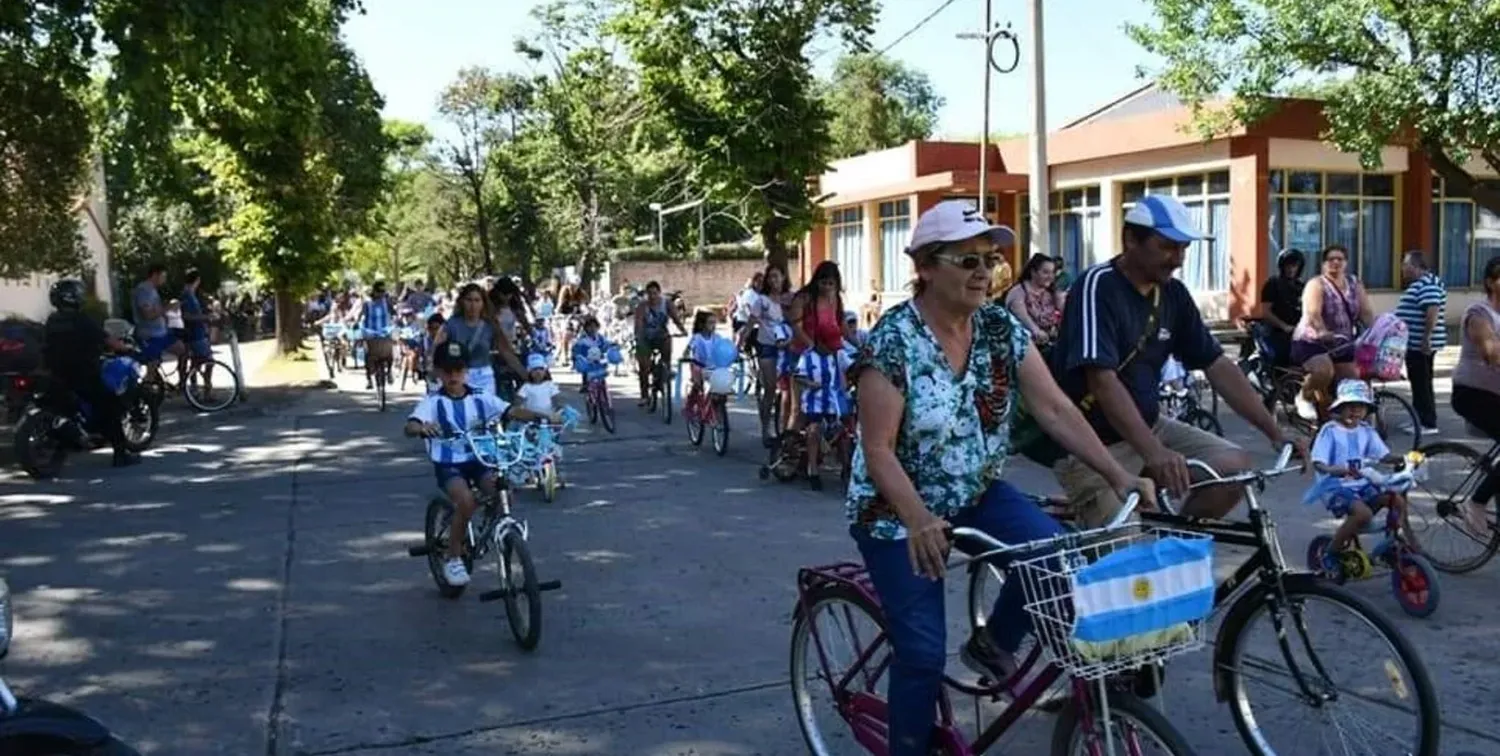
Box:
1073;537;1214;653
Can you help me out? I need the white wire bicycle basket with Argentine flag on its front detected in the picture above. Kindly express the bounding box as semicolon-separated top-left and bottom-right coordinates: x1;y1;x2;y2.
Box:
1011;525;1215;680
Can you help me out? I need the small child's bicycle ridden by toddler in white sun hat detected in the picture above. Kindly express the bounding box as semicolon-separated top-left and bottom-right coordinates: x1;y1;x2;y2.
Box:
1308;452;1442;617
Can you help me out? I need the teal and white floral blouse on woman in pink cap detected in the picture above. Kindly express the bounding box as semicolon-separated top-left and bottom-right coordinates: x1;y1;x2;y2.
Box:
845;302;1031;539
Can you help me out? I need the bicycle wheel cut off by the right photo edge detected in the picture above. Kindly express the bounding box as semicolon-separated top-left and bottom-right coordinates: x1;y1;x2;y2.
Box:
1406;441;1500;573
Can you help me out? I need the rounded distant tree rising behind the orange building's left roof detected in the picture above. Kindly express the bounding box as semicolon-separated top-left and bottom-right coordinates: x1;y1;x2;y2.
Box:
824;53;944;158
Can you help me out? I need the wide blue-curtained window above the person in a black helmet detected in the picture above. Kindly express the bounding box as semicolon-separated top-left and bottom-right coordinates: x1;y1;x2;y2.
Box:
1266;171;1398;288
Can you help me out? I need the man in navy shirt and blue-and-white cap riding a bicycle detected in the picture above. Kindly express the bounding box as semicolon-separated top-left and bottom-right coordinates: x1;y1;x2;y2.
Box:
1052;195;1307;527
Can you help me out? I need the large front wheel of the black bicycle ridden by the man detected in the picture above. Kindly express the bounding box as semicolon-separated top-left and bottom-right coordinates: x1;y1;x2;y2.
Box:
1215;575;1440;756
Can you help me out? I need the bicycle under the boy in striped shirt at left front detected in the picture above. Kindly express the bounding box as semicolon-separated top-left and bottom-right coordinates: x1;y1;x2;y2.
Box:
407;426;563;651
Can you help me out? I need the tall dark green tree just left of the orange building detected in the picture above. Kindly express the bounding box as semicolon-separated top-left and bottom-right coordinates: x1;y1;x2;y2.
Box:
615;0;878;270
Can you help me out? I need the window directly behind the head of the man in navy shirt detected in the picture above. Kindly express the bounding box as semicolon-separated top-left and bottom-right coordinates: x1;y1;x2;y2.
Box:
1121;171;1230;291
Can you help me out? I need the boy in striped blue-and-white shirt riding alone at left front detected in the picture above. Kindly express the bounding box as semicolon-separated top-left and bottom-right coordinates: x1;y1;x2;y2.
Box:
402;341;561;585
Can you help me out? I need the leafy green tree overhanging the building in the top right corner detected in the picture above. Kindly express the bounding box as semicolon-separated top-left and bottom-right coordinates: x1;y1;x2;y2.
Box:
1128;0;1500;213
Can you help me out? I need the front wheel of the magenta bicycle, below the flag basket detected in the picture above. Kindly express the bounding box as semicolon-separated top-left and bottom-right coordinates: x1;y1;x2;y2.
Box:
1052;692;1196;756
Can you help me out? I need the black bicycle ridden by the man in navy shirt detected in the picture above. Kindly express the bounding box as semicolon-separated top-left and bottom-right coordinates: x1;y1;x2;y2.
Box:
969;446;1442;756
